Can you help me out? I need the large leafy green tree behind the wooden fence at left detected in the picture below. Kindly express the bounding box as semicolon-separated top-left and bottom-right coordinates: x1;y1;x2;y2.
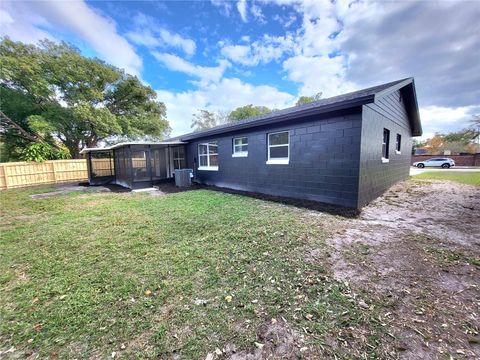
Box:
0;38;170;158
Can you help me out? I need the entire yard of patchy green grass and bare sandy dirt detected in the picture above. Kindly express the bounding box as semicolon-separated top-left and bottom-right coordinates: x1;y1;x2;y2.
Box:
0;181;480;360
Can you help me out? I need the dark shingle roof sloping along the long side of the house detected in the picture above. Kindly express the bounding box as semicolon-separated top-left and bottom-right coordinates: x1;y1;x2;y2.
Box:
168;78;421;141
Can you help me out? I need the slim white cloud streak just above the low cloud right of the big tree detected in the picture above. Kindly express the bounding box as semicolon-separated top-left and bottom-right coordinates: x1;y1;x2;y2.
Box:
152;51;229;83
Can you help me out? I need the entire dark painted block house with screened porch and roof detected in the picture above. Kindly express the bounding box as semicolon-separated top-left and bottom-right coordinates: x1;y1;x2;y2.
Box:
83;78;422;208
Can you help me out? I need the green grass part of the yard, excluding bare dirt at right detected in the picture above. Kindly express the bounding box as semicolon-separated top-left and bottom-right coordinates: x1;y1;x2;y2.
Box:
0;188;390;359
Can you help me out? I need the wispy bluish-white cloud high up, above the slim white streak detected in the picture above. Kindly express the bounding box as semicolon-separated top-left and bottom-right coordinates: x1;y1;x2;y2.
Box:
126;13;197;56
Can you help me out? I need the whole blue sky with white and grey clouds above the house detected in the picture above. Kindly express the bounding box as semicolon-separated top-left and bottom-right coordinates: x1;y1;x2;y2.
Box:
0;0;480;137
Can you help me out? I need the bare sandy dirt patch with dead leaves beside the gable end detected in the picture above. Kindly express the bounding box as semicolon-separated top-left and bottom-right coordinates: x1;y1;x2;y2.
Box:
327;181;480;359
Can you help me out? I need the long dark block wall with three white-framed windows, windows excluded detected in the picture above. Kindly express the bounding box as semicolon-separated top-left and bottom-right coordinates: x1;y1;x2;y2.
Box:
187;112;362;207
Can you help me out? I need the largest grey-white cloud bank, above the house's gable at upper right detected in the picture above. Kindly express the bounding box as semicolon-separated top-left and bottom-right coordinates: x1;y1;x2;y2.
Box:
266;0;480;134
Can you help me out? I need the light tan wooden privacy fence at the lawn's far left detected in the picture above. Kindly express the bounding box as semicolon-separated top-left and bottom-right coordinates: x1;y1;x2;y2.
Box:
0;159;89;190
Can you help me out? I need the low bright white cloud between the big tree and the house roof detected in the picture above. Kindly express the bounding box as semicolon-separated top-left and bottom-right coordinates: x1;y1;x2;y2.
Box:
157;78;295;136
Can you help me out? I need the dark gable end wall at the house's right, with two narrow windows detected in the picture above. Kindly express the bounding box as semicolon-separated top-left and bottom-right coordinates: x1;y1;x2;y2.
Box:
357;91;412;208
